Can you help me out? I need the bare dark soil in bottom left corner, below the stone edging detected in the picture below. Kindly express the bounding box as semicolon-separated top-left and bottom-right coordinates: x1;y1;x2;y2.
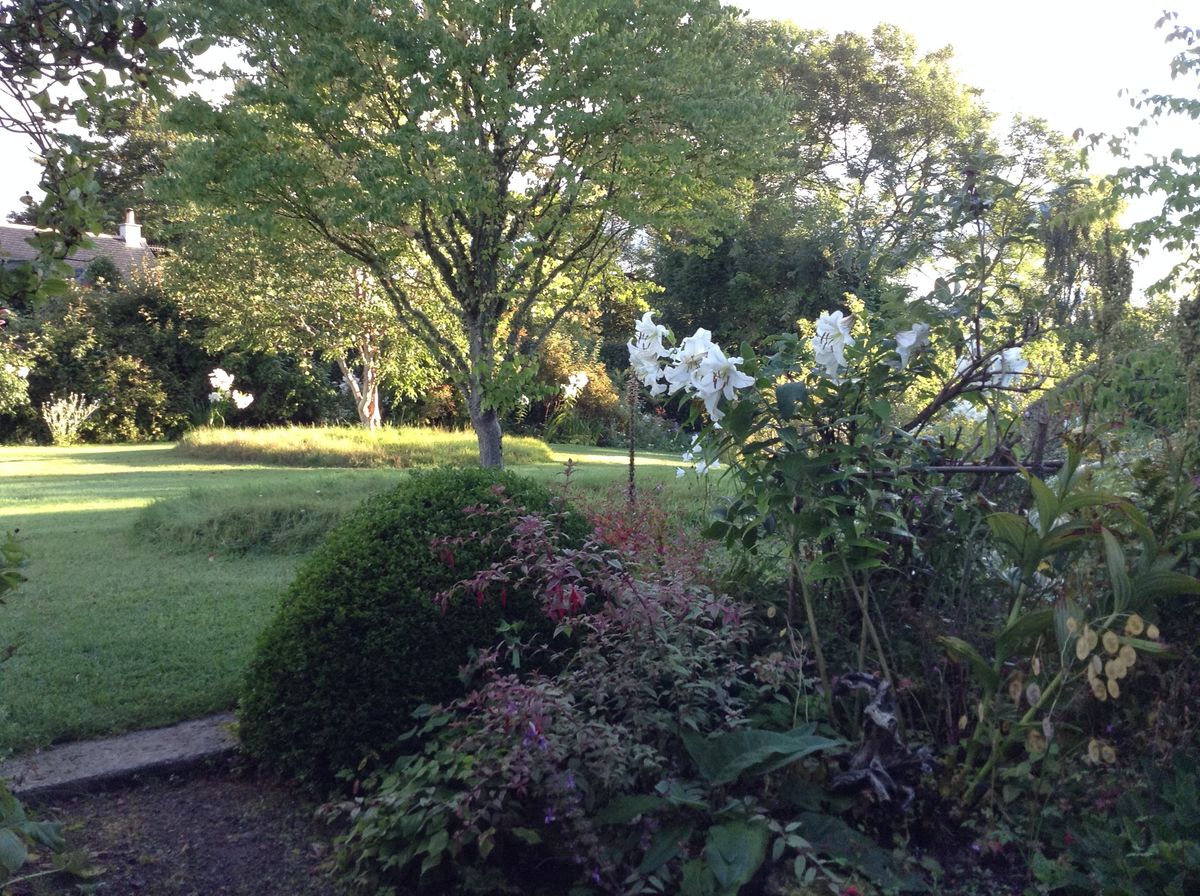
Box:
13;760;338;896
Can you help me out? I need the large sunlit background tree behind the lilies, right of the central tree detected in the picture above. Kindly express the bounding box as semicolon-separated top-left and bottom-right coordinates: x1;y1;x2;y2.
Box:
654;22;991;335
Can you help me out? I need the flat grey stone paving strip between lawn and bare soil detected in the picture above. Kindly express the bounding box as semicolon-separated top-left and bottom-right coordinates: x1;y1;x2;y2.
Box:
0;712;238;796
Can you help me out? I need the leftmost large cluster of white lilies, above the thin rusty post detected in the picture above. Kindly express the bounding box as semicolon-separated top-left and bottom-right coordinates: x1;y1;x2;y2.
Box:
629;312;754;422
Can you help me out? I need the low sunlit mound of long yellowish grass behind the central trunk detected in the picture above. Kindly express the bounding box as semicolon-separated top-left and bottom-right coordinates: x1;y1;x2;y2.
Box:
176;426;553;469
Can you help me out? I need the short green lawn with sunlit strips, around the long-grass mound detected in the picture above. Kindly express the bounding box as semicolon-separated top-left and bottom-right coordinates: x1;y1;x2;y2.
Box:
0;435;701;752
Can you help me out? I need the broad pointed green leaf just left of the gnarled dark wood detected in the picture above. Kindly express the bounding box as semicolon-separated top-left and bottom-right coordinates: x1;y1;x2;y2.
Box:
683;724;842;787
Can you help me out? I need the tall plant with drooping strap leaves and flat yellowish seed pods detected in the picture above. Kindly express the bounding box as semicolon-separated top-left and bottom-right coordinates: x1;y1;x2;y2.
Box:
941;451;1200;802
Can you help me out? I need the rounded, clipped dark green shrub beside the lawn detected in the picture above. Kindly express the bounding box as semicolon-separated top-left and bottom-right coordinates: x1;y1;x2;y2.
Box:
240;469;587;786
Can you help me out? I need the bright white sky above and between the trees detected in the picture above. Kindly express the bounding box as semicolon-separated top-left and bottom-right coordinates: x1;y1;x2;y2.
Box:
0;0;1200;289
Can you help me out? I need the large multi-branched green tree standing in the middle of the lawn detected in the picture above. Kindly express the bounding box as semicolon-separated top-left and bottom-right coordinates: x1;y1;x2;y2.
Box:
164;0;774;467
